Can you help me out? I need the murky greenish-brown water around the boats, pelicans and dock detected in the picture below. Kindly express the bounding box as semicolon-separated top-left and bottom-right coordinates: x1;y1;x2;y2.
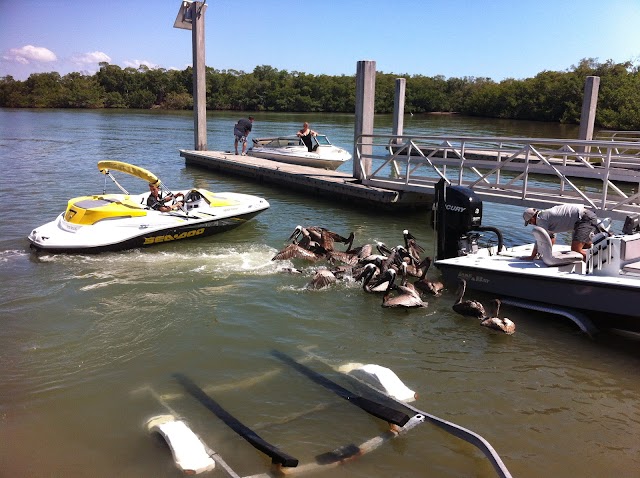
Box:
0;110;640;478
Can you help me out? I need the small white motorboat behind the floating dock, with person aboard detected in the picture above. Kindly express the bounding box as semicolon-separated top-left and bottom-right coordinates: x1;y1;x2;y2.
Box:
247;134;351;170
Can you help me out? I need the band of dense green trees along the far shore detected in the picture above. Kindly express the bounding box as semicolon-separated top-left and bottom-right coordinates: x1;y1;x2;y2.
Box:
0;58;640;130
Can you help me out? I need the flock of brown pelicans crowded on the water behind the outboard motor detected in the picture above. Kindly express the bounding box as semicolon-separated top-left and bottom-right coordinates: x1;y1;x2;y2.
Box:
272;226;515;334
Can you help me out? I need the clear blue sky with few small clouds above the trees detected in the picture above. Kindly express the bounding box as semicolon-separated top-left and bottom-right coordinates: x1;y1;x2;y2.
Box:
0;0;640;81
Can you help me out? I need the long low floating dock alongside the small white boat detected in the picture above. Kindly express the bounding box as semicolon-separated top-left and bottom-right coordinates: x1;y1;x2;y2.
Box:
180;150;433;212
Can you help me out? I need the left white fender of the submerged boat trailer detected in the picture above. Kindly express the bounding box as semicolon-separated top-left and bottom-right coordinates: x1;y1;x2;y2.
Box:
146;415;216;475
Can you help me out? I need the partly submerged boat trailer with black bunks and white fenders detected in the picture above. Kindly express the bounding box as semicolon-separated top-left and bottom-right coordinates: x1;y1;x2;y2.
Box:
139;350;511;478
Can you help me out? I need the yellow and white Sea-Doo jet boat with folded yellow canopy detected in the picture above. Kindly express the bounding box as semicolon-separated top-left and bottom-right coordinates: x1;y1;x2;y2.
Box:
28;161;269;253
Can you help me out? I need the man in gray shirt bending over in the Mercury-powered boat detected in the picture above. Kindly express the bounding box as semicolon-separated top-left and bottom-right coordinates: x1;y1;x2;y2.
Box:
522;204;598;260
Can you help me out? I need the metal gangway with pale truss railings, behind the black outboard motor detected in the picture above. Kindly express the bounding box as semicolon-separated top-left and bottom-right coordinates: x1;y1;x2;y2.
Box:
354;134;640;221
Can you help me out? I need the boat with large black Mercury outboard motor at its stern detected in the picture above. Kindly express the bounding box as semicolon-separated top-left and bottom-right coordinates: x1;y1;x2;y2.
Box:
433;180;640;334
